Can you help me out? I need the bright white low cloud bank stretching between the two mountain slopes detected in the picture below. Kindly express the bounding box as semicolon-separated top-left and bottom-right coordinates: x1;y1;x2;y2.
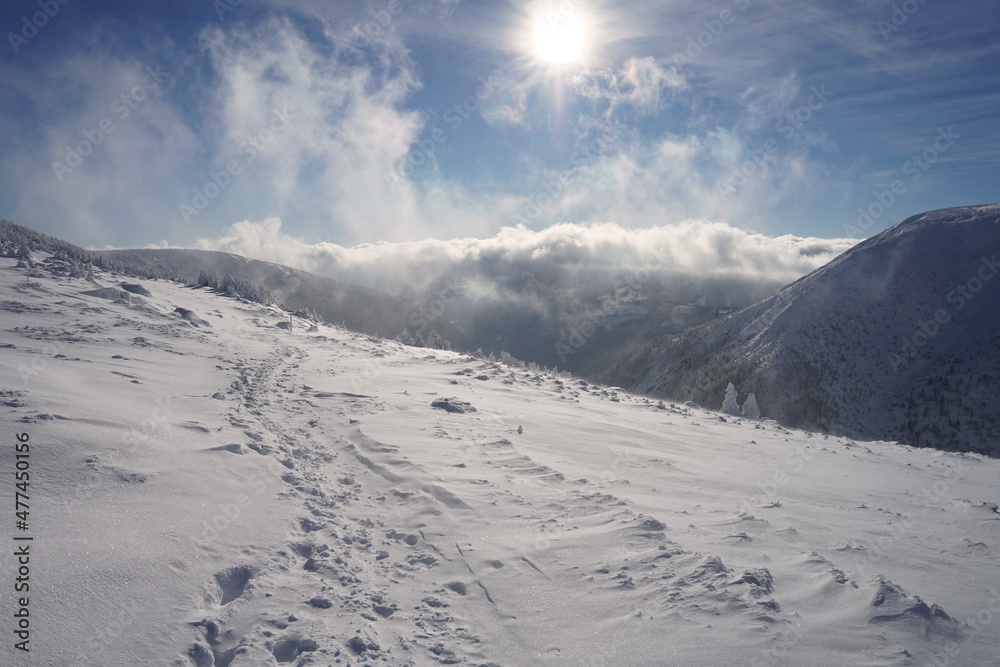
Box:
198;218;858;298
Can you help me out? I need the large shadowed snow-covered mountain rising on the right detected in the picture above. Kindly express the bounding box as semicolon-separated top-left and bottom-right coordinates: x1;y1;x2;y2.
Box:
600;205;1000;454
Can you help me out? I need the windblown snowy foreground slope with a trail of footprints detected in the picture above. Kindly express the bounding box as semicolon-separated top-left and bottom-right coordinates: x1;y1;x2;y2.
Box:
0;253;1000;667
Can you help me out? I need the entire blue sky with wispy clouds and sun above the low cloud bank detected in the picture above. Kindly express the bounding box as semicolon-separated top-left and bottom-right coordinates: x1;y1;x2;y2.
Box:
0;0;1000;252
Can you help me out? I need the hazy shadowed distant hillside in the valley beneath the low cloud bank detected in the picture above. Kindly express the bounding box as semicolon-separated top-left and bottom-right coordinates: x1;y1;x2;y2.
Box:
386;268;768;376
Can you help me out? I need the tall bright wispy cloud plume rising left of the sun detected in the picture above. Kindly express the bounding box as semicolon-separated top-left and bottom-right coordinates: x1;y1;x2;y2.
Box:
191;19;536;240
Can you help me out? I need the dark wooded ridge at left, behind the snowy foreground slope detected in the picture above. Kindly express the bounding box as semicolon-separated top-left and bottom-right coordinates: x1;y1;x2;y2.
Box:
0;218;475;351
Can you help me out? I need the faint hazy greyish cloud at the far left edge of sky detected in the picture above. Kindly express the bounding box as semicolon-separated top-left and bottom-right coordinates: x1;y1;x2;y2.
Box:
0;32;198;243
